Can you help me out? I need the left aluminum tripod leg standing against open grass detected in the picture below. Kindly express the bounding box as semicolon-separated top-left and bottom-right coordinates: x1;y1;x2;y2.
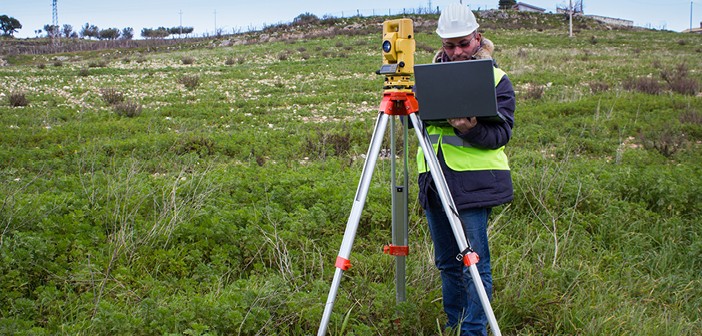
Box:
317;112;388;336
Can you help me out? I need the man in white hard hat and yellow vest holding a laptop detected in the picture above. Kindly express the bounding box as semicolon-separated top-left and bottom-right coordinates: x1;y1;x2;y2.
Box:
417;4;515;335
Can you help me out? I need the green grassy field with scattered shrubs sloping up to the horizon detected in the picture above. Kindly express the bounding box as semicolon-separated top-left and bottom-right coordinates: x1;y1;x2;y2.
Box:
0;11;702;335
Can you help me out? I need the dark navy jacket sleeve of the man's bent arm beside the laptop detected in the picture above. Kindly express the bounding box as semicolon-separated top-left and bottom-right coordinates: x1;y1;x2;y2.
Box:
454;75;516;149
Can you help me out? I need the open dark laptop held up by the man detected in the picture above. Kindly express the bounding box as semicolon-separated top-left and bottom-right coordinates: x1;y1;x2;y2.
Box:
414;59;504;125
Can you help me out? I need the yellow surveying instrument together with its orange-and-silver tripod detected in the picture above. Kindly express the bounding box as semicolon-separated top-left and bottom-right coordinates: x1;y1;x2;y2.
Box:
317;19;501;336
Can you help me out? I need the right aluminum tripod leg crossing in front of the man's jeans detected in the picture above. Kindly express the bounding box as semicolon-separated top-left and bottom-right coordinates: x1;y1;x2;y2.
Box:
409;113;502;336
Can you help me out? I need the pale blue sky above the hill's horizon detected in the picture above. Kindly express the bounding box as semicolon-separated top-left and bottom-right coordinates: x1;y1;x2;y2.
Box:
0;0;702;38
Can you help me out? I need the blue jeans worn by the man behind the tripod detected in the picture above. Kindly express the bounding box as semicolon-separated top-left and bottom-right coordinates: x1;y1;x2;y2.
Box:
424;205;492;336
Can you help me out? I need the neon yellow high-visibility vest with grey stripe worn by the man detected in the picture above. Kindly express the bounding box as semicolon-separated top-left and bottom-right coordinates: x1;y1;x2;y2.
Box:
417;68;509;173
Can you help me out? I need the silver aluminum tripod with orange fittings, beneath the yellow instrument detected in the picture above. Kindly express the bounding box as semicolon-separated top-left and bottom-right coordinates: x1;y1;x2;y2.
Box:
317;88;501;336
